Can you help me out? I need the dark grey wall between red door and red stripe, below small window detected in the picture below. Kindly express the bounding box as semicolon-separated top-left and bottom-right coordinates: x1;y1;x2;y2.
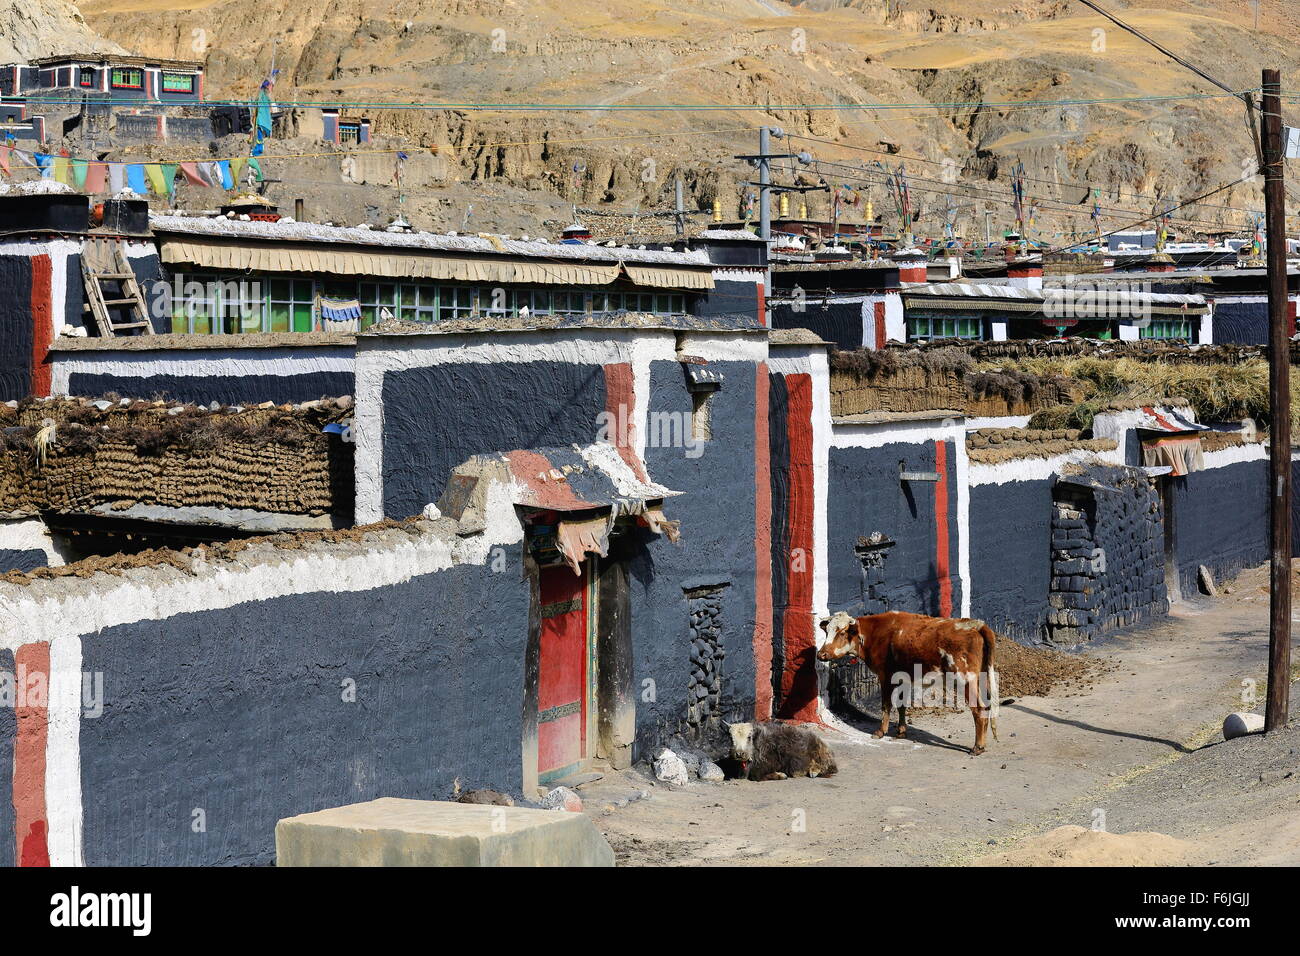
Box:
631;362;766;760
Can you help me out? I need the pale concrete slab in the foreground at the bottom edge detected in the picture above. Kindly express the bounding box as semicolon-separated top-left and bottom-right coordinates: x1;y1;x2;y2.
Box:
276;797;614;866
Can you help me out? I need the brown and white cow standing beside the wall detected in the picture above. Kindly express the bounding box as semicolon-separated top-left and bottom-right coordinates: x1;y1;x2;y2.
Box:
816;611;998;756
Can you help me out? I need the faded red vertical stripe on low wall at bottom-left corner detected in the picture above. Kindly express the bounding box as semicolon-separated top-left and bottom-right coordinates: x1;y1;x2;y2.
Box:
13;644;49;866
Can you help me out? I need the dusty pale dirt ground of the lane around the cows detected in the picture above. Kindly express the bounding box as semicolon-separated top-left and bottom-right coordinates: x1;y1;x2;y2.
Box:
581;568;1300;865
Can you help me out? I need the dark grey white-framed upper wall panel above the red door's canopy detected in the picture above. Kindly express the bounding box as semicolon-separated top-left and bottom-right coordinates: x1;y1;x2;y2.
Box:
382;362;605;518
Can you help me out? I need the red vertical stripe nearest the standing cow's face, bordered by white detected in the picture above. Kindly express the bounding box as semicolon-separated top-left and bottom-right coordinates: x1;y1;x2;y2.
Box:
780;375;818;721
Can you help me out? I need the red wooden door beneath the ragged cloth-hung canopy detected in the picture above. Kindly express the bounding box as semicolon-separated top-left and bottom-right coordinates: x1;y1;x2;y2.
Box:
537;564;589;784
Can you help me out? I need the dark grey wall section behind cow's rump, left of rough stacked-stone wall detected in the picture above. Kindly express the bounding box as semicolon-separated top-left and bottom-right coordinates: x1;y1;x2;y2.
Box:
970;479;1052;644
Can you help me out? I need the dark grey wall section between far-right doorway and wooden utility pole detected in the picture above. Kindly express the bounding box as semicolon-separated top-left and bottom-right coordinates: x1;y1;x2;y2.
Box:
1171;460;1263;594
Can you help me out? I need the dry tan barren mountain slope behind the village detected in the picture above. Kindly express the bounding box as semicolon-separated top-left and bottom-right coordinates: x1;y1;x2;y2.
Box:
45;0;1300;234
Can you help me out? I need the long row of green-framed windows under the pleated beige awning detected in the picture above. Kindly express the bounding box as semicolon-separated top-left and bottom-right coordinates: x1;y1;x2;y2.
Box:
172;274;686;333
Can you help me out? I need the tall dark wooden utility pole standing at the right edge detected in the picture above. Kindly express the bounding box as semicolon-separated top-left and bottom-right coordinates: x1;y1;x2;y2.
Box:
1262;70;1294;732
